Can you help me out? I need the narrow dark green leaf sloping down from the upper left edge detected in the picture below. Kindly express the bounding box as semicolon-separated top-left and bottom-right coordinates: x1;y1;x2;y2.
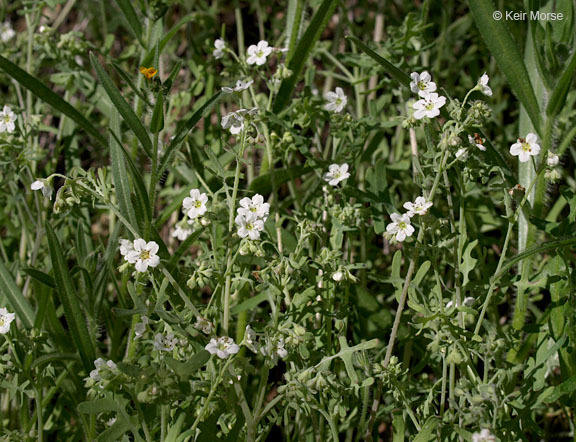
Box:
0;55;106;146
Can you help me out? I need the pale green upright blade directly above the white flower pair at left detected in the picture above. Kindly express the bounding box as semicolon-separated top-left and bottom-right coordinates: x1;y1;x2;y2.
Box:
109;109;138;230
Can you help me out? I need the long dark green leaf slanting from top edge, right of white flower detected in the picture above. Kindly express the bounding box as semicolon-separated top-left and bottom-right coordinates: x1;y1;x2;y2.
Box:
273;0;338;114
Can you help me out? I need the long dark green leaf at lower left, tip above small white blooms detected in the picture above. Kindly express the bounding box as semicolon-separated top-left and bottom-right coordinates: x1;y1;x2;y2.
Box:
46;222;95;371
